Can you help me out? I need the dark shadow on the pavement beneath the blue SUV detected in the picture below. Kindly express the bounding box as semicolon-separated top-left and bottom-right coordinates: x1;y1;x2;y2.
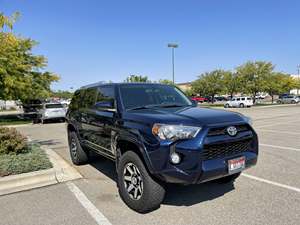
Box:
90;154;235;206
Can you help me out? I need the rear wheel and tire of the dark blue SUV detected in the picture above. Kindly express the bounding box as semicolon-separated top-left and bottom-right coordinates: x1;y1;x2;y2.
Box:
68;131;89;165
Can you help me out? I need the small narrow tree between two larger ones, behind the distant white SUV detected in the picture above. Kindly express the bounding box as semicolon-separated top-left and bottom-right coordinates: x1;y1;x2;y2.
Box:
223;71;241;98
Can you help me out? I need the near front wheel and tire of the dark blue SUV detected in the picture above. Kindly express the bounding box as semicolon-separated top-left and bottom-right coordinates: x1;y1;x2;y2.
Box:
117;151;165;213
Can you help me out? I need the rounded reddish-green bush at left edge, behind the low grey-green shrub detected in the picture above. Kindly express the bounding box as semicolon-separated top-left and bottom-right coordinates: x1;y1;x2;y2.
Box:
0;127;28;155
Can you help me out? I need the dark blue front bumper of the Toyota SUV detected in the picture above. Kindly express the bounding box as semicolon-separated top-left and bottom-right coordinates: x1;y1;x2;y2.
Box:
148;123;258;184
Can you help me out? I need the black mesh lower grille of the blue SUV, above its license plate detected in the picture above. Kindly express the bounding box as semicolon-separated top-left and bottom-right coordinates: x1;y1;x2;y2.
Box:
202;139;252;160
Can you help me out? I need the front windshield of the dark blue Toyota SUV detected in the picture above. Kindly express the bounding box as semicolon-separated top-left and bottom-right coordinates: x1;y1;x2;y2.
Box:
120;84;192;109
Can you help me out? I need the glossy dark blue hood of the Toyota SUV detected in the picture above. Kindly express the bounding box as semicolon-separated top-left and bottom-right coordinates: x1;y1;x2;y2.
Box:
124;107;245;126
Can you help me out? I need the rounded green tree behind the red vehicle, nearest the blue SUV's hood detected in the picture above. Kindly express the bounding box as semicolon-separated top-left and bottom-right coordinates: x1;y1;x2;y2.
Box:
192;70;224;103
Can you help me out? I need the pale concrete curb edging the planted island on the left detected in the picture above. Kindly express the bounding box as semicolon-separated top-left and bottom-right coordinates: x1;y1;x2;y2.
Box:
0;147;82;196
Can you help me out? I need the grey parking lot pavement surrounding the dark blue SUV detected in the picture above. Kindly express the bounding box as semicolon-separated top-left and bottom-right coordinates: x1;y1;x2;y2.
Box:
0;105;300;225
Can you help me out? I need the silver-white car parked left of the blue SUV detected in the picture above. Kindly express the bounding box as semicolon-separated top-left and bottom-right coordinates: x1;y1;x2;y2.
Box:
39;103;67;123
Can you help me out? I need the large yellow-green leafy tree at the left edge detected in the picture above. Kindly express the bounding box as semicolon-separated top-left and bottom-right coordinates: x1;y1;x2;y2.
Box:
0;13;59;100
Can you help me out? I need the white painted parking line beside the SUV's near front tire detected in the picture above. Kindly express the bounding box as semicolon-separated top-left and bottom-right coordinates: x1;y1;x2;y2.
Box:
67;182;111;225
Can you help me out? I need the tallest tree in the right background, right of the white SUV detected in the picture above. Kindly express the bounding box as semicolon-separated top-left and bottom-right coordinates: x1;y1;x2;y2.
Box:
237;61;274;103
